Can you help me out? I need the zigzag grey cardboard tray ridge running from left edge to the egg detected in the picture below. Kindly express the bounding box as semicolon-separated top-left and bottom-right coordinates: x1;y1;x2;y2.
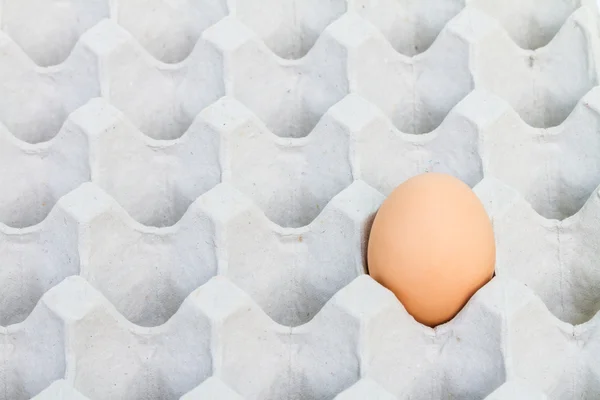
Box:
0;181;383;326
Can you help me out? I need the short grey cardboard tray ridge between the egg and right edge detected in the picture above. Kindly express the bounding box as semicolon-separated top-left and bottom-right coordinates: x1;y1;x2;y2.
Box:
475;177;600;324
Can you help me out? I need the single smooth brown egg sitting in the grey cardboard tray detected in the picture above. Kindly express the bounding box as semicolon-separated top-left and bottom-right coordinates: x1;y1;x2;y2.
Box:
367;173;496;326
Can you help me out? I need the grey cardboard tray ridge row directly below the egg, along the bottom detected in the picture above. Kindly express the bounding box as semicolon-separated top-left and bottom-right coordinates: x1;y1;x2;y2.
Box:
5;268;600;399
